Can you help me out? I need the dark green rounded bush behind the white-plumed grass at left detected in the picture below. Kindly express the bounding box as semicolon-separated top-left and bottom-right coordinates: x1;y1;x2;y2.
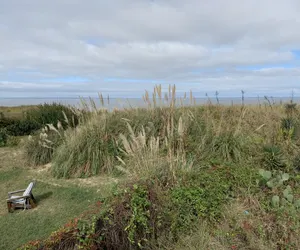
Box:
25;103;78;129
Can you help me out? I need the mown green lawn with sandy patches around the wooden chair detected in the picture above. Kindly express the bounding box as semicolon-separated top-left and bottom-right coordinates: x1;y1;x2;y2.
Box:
0;148;116;250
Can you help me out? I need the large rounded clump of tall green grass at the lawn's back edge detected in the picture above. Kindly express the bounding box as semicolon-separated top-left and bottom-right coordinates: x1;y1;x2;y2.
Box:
52;113;118;178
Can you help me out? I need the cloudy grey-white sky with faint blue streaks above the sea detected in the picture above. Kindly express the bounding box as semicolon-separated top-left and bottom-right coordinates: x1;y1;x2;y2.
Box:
0;0;300;98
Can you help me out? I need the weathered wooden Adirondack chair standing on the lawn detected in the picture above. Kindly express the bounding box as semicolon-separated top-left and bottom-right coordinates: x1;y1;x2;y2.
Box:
6;182;36;213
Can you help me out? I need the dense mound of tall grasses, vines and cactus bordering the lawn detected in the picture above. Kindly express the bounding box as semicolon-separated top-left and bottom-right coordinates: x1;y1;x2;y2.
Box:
4;87;300;249
